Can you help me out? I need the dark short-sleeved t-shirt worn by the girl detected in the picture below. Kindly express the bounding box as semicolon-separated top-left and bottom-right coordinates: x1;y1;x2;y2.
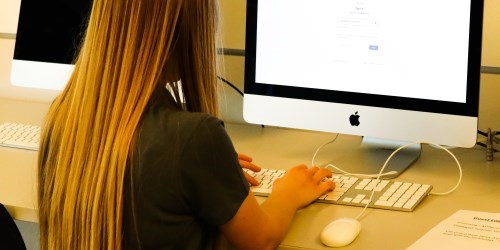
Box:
123;104;249;249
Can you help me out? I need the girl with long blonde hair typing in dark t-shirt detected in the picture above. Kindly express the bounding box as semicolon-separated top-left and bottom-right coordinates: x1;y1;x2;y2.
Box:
38;0;333;249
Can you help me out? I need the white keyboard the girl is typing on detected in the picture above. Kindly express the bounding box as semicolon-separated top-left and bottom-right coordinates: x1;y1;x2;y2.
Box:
245;169;432;212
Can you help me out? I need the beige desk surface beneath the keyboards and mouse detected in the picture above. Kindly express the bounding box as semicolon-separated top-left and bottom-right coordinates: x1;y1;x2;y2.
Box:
0;99;500;249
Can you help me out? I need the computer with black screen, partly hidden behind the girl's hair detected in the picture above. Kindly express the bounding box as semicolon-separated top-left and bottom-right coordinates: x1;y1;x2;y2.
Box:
11;0;92;91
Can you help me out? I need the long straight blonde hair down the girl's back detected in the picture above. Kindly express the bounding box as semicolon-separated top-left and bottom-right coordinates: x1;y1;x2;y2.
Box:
38;0;218;249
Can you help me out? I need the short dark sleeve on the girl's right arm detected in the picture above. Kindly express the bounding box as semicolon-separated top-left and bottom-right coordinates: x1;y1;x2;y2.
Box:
180;116;249;226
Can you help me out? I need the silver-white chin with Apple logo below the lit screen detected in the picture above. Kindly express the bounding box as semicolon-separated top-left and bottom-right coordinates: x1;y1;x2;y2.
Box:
243;94;478;148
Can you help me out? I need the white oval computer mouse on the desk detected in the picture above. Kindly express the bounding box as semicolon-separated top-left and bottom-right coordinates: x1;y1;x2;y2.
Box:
320;218;361;247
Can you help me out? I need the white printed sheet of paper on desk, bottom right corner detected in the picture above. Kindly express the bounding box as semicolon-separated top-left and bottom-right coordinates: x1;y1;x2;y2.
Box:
407;210;500;250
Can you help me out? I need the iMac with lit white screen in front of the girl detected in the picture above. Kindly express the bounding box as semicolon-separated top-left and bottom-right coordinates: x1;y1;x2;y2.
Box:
243;0;484;176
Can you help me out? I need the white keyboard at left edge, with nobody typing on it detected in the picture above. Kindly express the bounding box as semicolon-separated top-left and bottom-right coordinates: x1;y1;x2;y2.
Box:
0;122;41;151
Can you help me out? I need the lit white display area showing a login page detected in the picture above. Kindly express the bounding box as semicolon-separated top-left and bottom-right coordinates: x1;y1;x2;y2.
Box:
256;0;470;103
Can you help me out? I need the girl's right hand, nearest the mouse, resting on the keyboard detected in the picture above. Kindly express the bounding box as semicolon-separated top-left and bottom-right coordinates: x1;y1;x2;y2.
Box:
271;164;335;209
